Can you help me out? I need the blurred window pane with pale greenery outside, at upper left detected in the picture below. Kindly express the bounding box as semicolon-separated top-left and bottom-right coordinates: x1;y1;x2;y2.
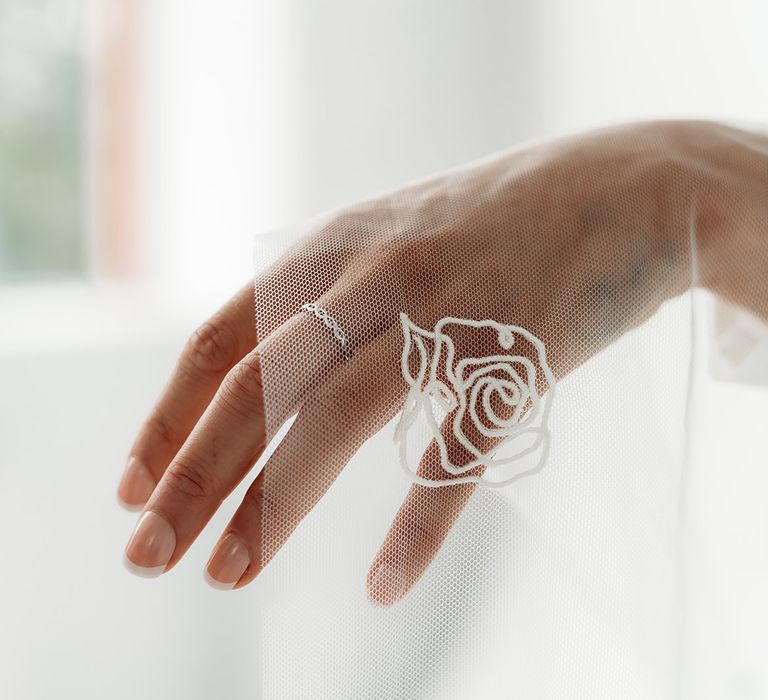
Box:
0;0;85;282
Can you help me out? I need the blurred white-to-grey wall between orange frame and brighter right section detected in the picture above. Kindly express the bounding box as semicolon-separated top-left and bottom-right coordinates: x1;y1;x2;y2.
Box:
136;0;543;306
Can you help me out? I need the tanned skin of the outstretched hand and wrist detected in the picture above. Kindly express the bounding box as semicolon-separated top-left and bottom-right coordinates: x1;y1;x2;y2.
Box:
118;121;768;605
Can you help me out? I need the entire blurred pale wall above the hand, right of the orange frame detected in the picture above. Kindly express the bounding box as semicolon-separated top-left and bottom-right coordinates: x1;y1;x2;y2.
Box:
135;0;768;308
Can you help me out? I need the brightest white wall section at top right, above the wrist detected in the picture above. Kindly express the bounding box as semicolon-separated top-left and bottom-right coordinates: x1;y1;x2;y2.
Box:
542;0;768;131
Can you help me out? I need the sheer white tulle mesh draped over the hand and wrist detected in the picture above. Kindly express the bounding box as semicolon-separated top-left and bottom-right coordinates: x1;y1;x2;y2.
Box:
249;122;768;698
